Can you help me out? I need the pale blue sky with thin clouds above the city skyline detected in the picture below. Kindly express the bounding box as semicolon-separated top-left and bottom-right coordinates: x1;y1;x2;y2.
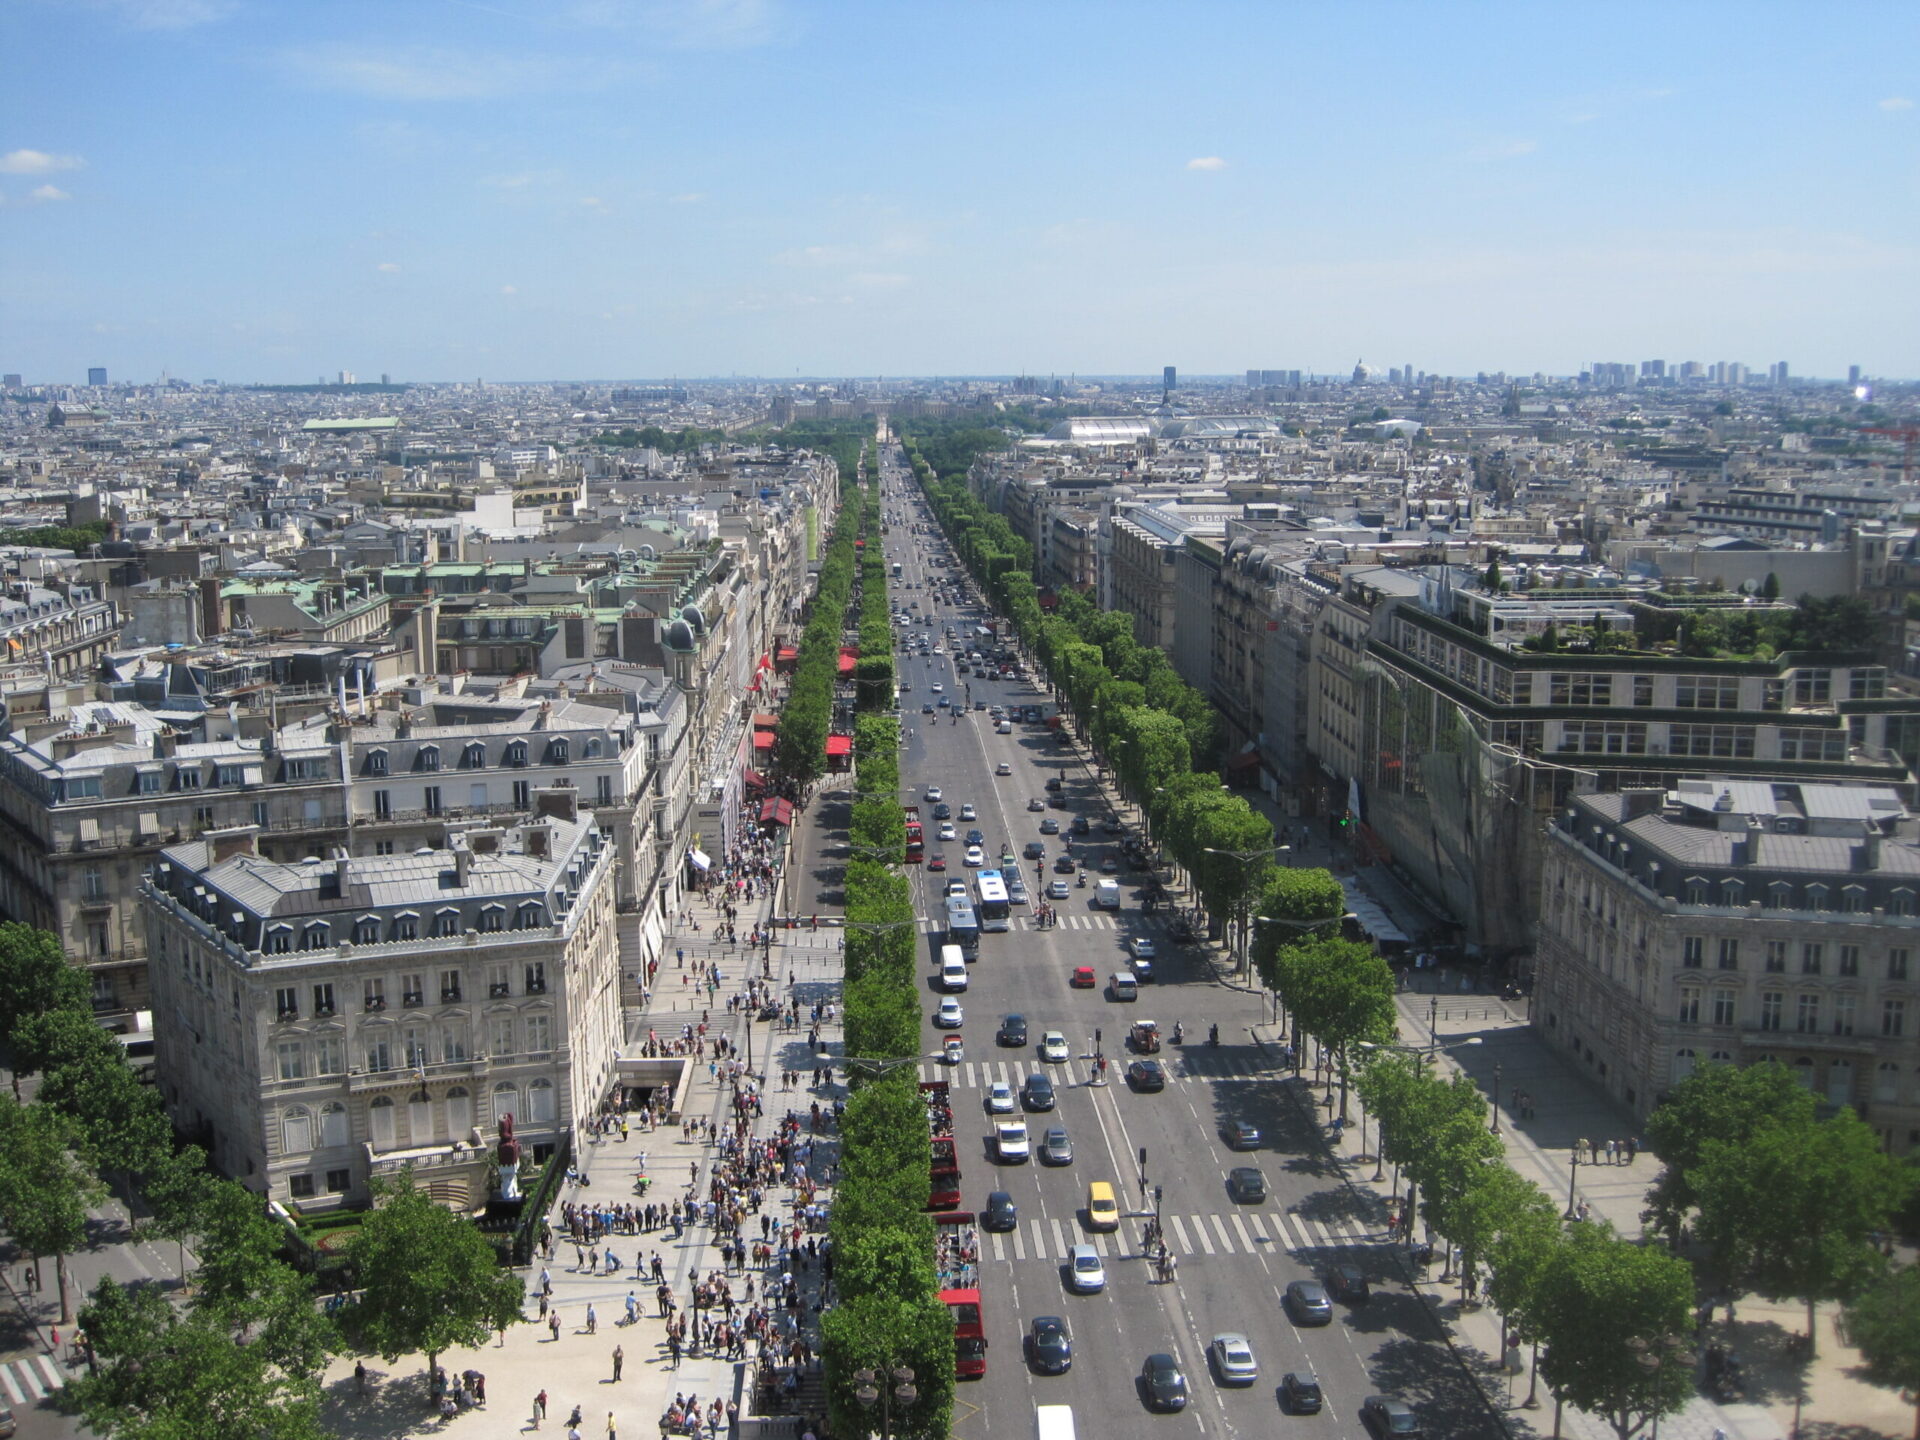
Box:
0;0;1920;382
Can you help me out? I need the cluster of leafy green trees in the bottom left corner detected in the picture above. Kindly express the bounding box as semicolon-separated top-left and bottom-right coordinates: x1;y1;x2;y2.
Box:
0;924;522;1440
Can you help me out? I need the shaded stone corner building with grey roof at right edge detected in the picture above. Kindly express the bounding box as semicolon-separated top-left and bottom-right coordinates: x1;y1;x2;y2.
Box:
1532;776;1920;1154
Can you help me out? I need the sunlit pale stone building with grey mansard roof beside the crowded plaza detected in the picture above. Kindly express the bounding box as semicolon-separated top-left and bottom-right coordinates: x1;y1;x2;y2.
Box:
138;806;620;1208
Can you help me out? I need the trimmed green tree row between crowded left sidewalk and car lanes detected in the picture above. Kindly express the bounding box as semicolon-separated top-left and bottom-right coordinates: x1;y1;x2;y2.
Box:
820;464;954;1440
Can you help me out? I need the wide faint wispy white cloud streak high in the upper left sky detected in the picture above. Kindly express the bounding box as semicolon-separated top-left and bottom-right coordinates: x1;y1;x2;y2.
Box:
280;44;618;100
